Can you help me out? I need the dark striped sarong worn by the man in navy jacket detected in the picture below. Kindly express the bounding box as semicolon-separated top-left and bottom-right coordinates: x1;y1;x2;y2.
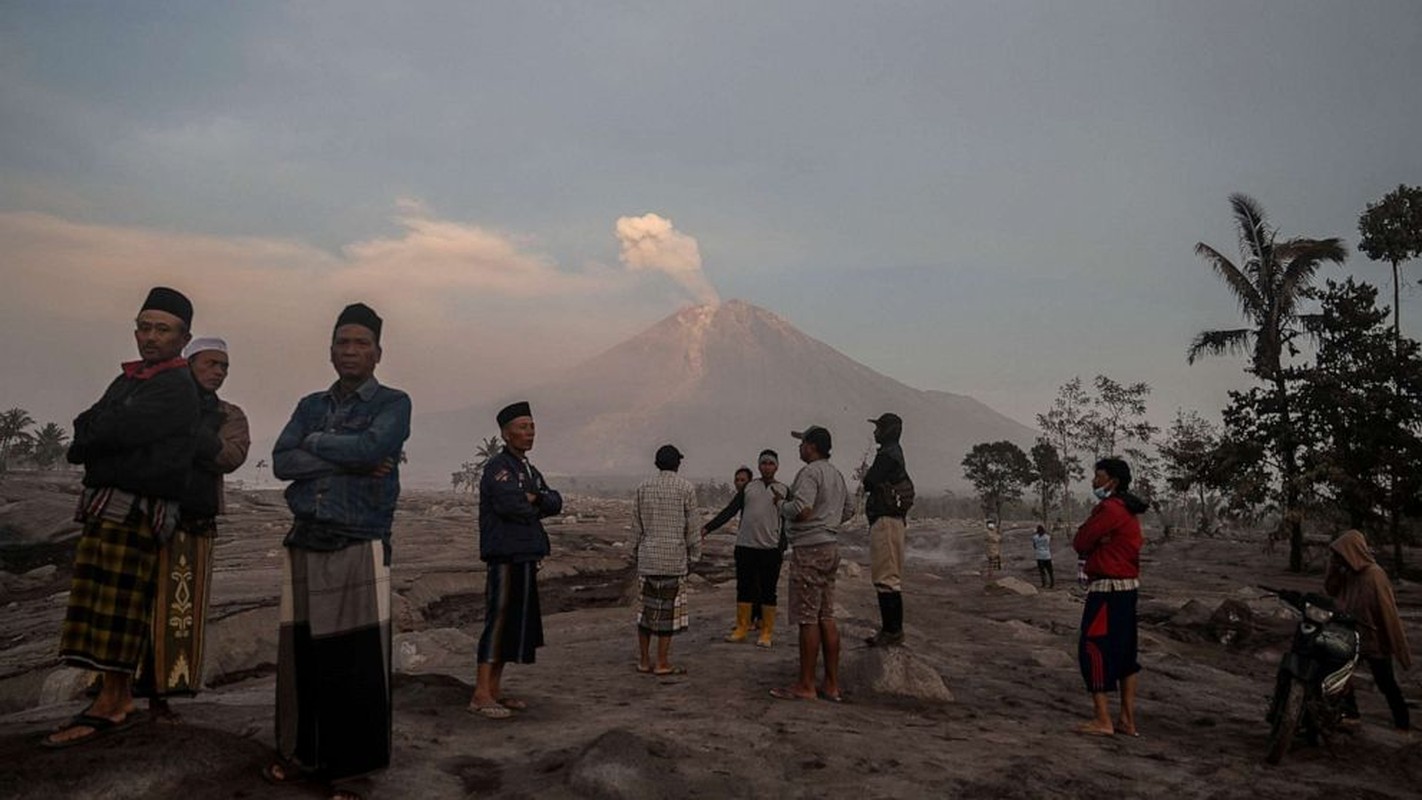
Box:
478;561;543;664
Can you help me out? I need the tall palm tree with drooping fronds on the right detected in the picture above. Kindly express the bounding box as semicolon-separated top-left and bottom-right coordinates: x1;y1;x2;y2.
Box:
1187;195;1348;573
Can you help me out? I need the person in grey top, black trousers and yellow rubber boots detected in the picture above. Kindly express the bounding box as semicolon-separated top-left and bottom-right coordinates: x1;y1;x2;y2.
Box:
701;450;789;647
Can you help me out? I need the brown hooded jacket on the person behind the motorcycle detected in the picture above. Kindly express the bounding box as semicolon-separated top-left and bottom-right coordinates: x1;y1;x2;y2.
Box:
1324;530;1412;669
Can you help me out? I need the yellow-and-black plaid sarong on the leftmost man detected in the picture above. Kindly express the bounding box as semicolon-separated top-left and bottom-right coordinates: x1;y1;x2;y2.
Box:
60;514;158;674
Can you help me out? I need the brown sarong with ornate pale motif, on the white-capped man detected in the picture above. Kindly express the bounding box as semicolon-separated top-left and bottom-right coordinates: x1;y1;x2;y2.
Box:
134;523;216;698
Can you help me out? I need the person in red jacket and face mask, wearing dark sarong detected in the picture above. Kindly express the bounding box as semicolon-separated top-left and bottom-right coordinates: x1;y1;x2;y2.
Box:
1072;459;1149;736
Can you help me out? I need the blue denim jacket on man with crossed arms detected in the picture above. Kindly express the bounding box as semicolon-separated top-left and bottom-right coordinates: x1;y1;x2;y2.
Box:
272;378;411;541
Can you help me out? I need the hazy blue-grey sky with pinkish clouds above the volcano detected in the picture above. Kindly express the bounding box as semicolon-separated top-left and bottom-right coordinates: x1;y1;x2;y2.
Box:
0;0;1422;458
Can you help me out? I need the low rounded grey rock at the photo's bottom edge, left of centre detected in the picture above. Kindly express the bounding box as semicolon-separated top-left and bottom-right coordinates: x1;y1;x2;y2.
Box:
567;728;678;800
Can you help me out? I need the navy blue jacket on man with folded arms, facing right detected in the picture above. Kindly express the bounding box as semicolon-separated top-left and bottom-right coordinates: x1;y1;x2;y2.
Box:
479;448;563;561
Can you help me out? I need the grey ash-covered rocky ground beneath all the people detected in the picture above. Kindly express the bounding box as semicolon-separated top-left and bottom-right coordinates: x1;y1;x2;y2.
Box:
0;473;1422;800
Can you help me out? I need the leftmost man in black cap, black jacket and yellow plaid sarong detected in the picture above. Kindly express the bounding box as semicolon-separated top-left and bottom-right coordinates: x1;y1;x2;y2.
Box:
43;287;198;747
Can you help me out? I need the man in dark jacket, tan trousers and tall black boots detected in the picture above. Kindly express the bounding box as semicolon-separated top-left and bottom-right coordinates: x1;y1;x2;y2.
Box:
863;413;909;647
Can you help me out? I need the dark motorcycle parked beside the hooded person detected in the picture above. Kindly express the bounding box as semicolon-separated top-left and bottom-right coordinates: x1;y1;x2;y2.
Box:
1260;585;1359;764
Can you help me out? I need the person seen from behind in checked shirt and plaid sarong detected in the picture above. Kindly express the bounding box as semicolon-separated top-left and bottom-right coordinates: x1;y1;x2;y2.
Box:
631;445;701;675
